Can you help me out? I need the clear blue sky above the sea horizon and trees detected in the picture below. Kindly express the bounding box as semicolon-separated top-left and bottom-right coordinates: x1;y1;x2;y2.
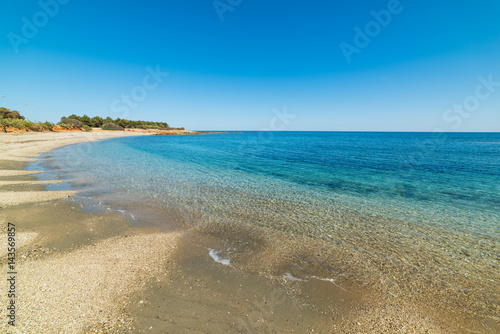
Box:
0;0;500;131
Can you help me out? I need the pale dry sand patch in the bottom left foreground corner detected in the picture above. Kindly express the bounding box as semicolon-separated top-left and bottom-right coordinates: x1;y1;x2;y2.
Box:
0;233;179;333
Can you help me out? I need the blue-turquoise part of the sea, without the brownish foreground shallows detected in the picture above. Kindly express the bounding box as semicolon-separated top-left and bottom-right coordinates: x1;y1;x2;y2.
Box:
49;132;500;237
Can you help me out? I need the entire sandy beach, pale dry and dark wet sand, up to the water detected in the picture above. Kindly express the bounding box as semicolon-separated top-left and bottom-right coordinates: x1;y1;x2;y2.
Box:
0;132;496;333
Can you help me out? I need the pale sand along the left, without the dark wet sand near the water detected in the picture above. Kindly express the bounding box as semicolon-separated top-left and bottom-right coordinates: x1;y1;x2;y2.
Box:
0;131;184;333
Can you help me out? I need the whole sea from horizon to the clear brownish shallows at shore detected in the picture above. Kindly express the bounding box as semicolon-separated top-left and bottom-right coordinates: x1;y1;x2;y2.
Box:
45;132;500;314
